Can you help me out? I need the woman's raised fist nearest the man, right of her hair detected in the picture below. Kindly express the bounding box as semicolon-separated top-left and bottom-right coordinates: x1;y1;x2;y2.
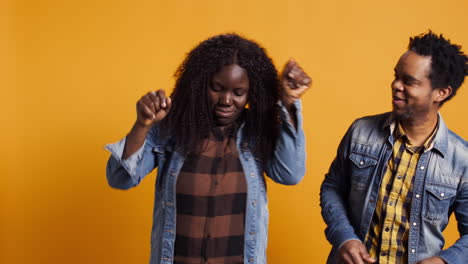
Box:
280;59;312;109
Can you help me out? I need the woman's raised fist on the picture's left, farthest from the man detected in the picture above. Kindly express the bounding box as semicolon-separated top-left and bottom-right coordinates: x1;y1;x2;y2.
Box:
136;90;171;127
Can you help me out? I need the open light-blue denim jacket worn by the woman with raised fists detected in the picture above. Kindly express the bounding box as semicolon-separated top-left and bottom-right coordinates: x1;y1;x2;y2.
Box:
106;100;305;264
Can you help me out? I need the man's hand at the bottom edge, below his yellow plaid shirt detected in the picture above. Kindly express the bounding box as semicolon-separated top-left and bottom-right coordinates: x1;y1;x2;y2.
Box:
337;240;375;264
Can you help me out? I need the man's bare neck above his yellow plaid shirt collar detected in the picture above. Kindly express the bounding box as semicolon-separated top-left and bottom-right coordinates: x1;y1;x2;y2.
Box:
400;113;438;146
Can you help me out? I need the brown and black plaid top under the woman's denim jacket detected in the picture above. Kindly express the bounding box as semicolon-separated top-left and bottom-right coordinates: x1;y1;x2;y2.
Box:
174;128;247;264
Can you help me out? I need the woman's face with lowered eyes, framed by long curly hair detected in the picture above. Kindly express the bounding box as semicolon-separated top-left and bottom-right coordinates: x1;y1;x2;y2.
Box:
208;64;250;126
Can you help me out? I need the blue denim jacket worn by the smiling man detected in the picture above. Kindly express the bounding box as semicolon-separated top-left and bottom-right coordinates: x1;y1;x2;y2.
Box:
320;113;468;264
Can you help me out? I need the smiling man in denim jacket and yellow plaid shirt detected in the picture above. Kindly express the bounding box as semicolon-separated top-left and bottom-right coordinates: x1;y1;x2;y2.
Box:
320;32;468;264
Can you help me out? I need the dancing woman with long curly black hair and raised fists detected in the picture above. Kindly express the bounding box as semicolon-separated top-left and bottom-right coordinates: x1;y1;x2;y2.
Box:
106;34;311;264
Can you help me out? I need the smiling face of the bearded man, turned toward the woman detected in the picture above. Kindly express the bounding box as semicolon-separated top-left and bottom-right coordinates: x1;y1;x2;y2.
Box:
392;51;439;121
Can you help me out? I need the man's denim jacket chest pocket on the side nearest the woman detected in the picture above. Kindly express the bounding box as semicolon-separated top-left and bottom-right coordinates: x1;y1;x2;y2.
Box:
349;152;377;190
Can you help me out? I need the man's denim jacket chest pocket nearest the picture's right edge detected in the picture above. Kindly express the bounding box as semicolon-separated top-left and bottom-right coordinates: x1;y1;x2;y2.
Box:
423;183;457;223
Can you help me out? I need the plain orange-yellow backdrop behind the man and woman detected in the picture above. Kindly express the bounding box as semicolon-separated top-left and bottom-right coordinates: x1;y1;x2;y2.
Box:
0;0;468;264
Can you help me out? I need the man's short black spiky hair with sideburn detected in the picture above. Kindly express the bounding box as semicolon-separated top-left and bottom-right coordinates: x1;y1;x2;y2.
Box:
408;30;468;105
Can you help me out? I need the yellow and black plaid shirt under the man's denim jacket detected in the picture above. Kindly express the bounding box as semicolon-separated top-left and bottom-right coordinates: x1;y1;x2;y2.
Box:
364;123;437;264
